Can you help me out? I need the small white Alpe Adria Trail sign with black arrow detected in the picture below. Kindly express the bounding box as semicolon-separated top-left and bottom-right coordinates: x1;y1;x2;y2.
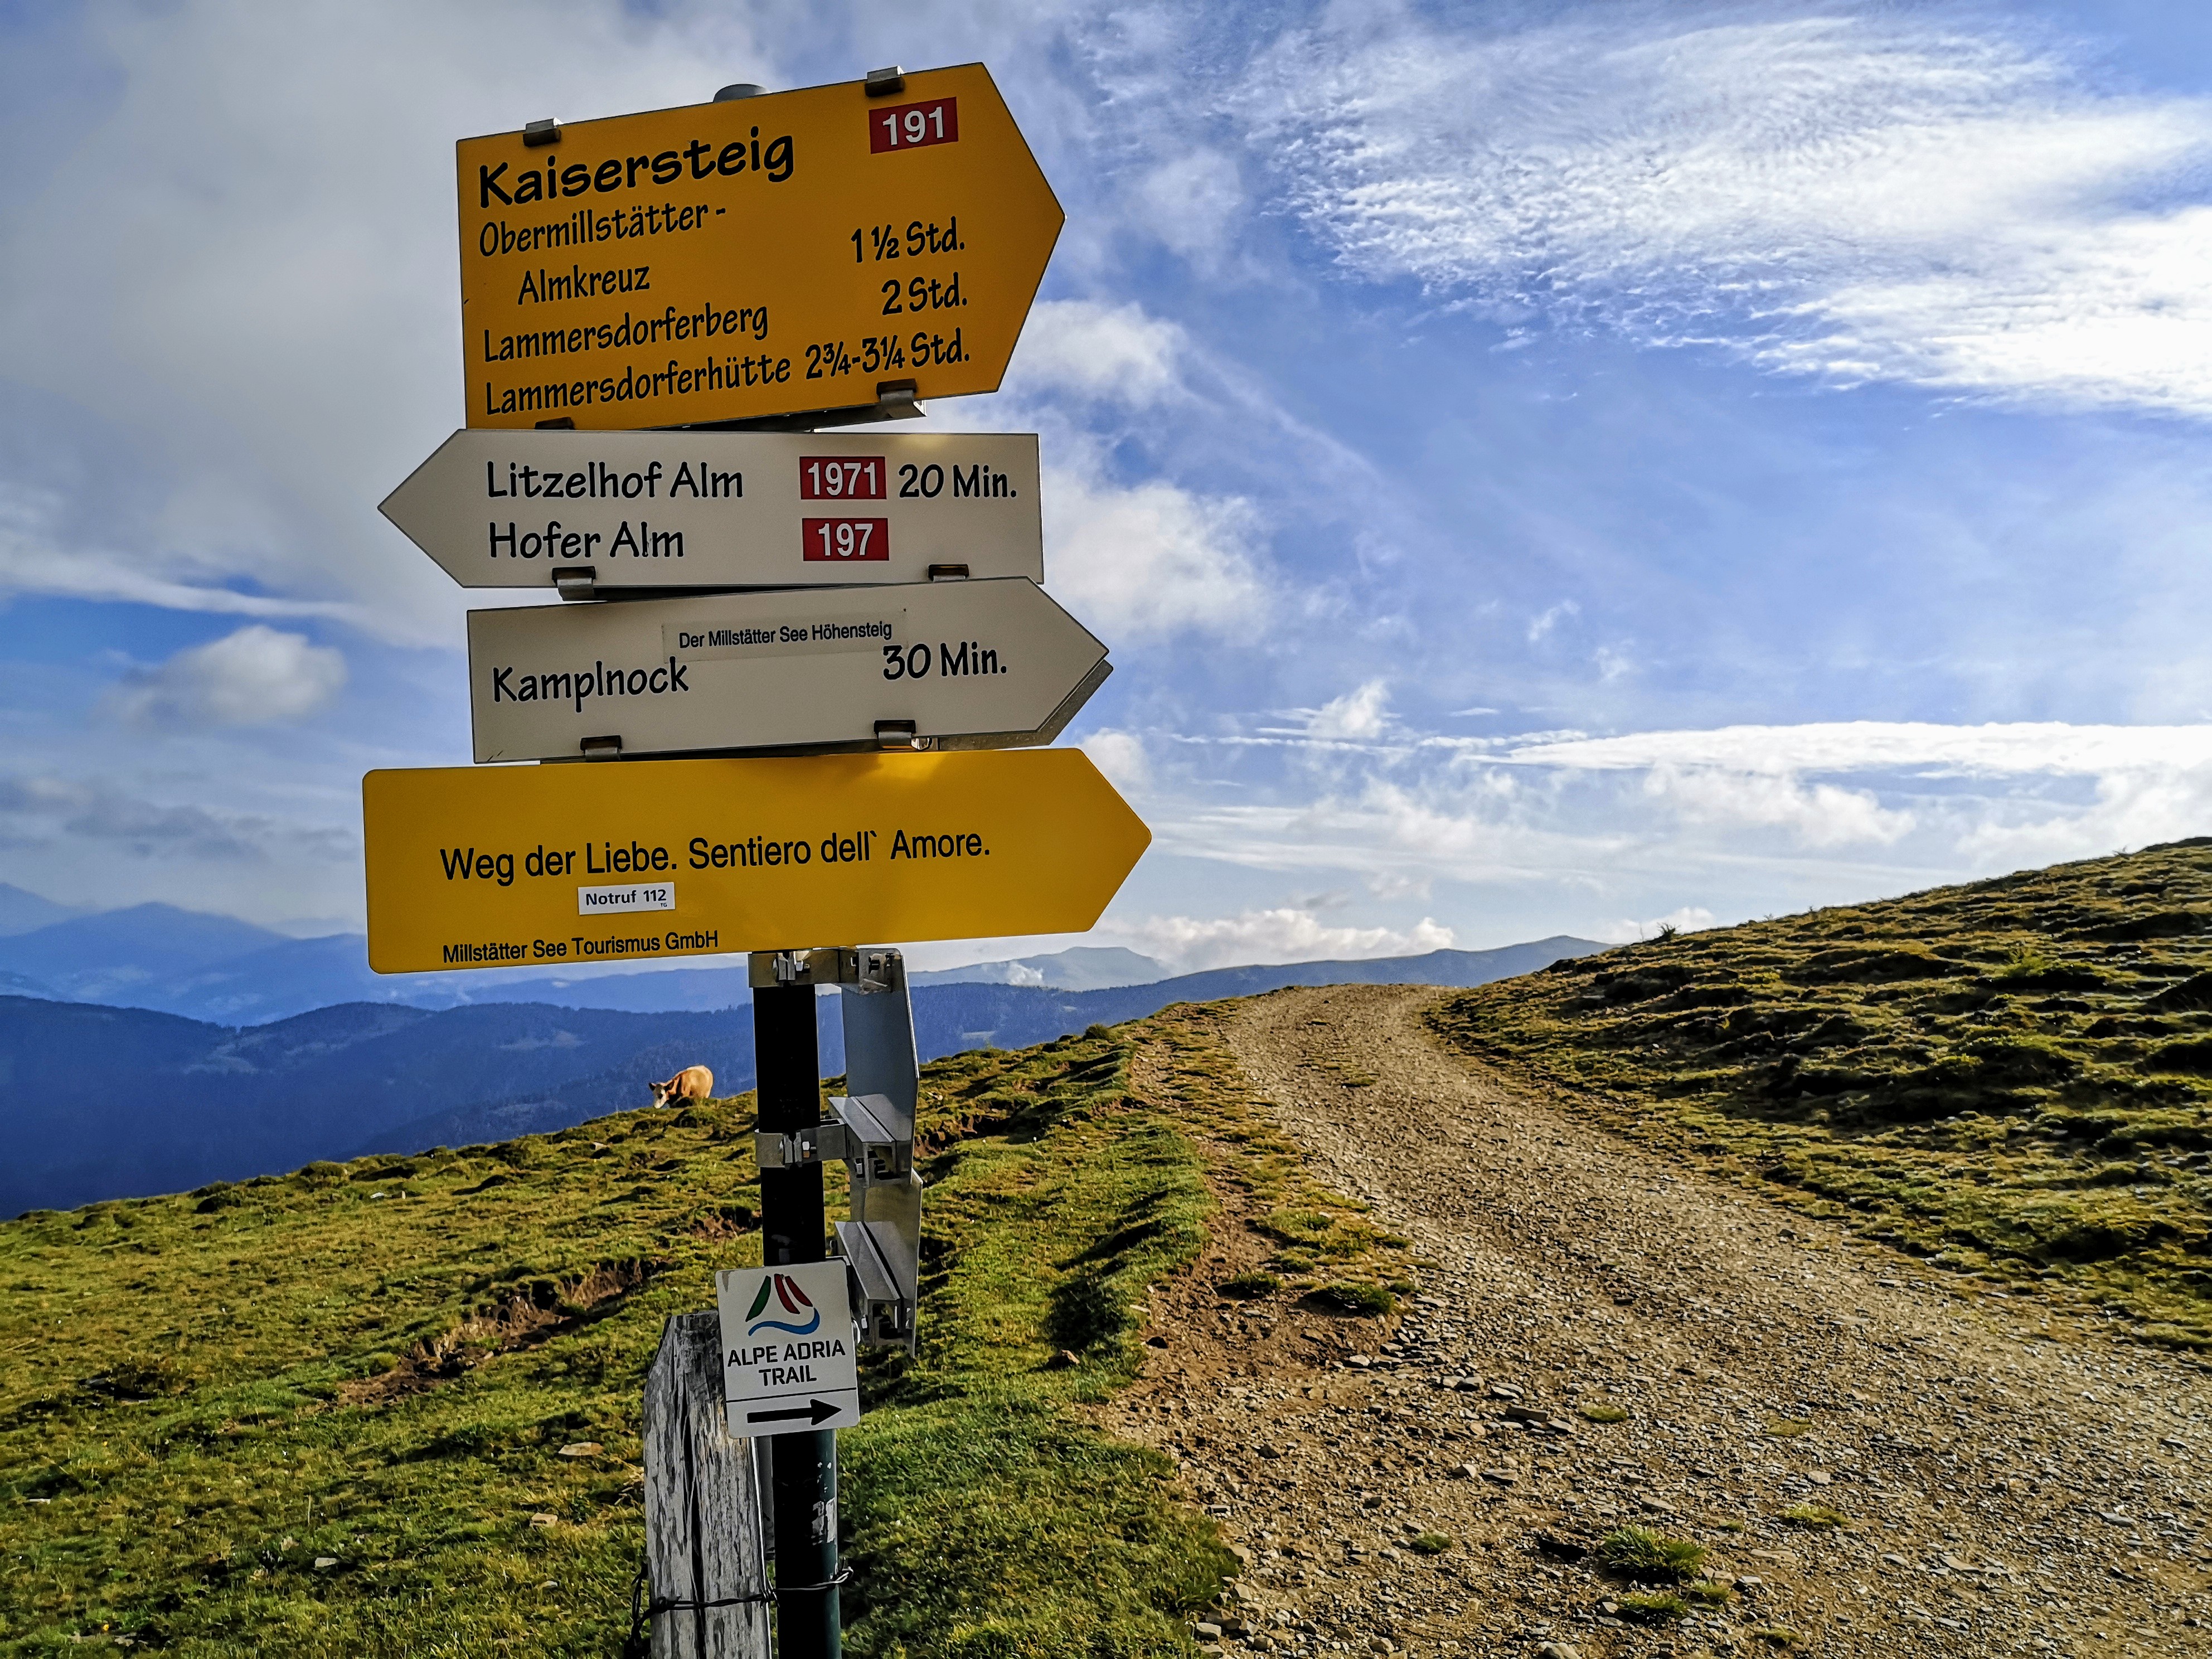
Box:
715;1261;861;1440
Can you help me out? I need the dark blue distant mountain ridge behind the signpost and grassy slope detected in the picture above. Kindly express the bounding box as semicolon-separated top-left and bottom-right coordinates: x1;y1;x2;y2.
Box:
0;942;1604;1214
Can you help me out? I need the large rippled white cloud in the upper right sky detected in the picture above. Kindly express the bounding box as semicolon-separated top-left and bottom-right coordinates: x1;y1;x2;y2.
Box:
1239;4;2212;414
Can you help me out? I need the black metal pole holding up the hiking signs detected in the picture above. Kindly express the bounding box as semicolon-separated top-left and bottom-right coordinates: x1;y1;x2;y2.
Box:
752;984;845;1659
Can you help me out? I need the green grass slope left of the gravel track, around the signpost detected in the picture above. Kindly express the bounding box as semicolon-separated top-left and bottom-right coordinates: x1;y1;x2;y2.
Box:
0;1022;1232;1659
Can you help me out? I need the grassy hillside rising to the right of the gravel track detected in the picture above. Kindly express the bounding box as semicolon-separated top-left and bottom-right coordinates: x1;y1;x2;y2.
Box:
1433;838;2212;1347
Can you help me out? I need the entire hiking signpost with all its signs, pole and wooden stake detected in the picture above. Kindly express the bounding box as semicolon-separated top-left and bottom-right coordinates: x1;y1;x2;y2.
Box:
378;64;1114;1659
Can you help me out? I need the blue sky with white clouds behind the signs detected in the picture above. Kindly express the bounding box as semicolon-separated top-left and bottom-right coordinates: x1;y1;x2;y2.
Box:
0;0;2212;967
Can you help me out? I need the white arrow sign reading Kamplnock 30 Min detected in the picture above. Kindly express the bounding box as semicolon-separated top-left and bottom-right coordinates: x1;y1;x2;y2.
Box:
469;578;1108;761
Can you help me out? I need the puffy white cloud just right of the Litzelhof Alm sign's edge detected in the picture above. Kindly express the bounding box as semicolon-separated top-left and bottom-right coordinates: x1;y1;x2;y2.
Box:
1044;467;1268;644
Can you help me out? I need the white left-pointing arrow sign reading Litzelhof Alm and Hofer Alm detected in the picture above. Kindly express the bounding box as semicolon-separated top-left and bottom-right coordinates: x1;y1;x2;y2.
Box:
382;429;1044;588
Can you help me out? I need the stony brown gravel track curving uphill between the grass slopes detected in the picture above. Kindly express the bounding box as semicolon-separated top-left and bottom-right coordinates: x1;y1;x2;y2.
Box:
1106;987;2212;1659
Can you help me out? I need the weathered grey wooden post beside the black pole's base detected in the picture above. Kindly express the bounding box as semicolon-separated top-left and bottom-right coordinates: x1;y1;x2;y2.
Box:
646;1309;770;1659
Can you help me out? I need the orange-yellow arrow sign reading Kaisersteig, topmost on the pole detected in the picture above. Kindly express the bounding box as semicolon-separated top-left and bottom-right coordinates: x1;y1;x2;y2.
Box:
458;64;1062;429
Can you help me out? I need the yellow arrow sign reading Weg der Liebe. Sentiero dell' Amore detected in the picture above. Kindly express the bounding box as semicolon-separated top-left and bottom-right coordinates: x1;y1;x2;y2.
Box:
361;750;1152;973
